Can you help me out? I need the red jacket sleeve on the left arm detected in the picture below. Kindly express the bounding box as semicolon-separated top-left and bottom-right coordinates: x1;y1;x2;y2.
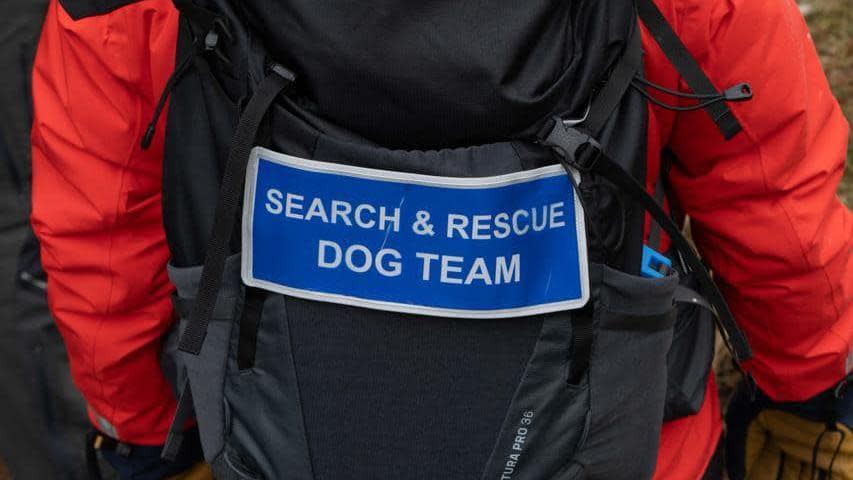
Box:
32;0;177;445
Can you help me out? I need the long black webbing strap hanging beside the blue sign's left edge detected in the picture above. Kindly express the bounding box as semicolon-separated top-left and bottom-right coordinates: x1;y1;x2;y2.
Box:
179;65;296;355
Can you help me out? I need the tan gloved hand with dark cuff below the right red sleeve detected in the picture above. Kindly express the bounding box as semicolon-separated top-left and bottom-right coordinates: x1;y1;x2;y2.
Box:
726;377;853;480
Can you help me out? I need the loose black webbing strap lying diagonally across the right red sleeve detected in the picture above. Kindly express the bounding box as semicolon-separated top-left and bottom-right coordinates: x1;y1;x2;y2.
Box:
636;0;742;140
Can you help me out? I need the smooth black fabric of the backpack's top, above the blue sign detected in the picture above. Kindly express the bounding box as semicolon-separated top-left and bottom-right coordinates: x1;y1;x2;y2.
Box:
199;0;634;149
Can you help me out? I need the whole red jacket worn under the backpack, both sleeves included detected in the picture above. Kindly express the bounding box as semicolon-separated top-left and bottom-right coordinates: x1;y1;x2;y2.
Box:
33;0;853;479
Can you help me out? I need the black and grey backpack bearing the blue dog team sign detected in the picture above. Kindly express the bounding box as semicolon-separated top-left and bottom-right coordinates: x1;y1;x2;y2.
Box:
143;0;751;480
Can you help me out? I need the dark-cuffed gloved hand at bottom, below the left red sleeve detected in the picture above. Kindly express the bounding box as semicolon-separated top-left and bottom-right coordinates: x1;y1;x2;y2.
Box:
86;428;213;480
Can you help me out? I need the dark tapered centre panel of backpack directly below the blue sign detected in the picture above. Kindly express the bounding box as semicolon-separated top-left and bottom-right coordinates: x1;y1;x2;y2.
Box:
284;299;542;480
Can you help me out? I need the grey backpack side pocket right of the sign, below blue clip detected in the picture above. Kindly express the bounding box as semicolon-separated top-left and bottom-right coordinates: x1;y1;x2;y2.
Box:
575;265;678;480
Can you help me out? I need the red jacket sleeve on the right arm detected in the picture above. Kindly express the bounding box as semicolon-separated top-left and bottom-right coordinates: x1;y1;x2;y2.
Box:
662;0;853;401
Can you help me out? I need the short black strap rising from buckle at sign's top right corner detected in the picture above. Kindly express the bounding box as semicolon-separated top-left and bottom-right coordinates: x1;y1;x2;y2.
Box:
584;21;643;135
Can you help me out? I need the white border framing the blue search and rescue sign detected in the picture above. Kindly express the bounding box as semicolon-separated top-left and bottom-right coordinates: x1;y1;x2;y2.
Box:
241;147;589;319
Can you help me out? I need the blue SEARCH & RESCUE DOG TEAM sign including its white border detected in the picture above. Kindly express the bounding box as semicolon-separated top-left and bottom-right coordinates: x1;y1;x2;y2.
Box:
242;147;589;318
